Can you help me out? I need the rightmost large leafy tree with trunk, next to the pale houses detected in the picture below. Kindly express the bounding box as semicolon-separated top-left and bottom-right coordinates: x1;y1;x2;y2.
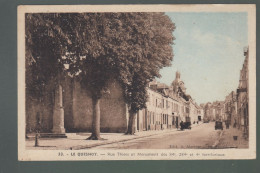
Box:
114;13;175;134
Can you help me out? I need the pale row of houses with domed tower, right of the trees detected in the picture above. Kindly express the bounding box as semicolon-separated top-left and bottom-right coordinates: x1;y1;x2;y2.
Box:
136;71;203;131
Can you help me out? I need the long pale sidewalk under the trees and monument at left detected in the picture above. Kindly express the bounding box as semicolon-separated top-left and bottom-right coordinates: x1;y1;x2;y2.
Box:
26;129;177;150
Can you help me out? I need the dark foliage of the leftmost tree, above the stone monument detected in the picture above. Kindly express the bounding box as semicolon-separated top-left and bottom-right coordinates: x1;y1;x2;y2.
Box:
25;13;71;100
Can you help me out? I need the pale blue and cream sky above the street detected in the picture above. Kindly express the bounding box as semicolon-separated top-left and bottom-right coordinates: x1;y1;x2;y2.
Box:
157;12;248;104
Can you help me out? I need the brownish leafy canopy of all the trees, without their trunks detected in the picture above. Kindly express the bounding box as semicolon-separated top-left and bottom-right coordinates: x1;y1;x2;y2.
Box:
26;13;175;112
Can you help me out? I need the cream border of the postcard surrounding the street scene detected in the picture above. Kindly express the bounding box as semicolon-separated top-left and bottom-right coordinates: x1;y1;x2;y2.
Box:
17;4;256;161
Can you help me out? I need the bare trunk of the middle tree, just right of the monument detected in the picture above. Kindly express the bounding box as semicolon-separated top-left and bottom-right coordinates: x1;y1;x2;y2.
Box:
87;97;101;140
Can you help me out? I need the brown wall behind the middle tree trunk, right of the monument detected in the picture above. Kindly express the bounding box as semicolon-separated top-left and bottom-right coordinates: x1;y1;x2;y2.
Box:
71;79;128;132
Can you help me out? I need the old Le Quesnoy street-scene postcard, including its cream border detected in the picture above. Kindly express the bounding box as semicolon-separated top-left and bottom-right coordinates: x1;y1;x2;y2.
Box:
17;4;256;161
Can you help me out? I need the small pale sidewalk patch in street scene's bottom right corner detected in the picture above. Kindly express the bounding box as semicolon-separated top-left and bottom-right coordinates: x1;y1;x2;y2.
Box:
217;127;249;148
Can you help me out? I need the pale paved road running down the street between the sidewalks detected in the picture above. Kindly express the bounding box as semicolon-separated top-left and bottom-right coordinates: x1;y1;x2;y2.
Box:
93;123;220;149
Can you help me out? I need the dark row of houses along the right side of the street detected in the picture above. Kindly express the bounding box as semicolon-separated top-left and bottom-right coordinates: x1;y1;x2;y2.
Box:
201;47;249;138
